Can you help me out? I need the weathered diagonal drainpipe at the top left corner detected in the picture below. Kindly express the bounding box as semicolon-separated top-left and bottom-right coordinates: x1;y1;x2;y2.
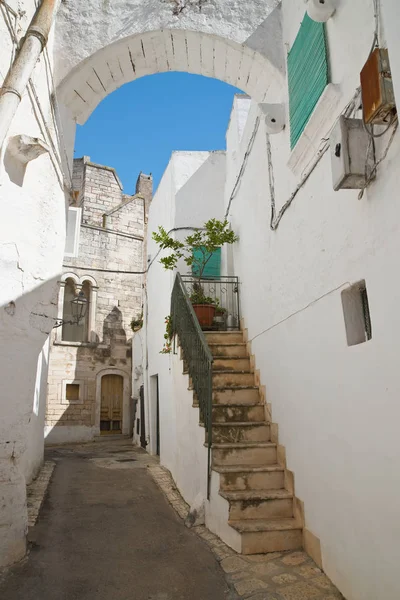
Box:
0;0;59;149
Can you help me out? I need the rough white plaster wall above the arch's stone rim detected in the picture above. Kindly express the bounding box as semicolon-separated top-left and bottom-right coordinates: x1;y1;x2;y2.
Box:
57;0;279;84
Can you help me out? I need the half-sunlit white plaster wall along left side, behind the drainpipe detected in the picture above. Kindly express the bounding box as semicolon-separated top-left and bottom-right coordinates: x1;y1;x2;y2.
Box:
0;0;65;566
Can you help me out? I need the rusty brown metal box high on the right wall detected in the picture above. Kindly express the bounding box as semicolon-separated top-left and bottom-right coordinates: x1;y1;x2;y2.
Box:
360;48;396;125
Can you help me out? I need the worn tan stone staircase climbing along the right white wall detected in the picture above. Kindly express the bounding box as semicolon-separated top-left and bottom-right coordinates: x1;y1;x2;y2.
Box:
205;332;302;554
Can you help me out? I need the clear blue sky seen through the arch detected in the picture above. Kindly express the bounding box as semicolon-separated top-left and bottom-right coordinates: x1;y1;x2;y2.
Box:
75;73;244;194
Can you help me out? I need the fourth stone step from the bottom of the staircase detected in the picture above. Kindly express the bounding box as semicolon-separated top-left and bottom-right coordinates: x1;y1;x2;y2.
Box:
212;442;277;465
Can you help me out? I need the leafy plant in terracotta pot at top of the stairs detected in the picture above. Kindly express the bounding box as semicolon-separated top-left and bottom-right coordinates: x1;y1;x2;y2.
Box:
152;219;239;328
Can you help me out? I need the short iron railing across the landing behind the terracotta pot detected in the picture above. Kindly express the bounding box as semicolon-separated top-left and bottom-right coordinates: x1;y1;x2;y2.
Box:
182;275;240;331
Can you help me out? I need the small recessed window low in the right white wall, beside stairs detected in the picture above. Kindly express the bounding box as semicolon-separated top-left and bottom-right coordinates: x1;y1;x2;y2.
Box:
342;280;372;346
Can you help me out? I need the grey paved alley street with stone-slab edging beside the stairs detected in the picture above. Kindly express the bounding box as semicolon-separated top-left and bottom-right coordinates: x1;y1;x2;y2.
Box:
0;439;342;600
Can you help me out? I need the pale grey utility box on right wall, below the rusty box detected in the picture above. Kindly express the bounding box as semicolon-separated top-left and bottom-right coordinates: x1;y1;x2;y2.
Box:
329;116;374;191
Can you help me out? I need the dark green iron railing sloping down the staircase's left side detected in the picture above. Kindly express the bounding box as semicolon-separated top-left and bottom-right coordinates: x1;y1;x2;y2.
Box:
171;273;213;498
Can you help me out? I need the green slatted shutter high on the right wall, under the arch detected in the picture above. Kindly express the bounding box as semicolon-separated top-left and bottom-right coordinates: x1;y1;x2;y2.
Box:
288;13;329;148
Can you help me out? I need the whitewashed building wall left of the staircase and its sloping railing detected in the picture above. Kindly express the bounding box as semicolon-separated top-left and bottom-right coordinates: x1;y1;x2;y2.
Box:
144;152;225;503
